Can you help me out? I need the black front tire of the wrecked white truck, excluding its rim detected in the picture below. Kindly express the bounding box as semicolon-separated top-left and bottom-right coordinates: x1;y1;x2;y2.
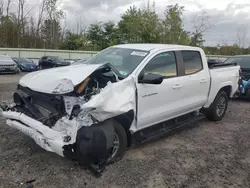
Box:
107;121;128;164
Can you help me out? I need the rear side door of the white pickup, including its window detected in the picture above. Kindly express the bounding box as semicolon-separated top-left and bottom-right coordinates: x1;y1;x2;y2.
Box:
180;51;210;113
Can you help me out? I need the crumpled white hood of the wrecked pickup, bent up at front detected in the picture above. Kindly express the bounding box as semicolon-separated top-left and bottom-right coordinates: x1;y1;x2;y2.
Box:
19;64;103;94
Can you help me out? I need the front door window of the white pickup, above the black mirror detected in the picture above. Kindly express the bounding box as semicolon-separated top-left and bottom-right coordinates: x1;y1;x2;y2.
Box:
144;52;177;77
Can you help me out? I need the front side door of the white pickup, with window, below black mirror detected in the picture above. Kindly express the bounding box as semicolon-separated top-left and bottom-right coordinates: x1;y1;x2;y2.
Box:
137;52;183;129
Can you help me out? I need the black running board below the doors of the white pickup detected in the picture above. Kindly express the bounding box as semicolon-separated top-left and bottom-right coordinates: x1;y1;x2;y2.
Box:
132;113;205;144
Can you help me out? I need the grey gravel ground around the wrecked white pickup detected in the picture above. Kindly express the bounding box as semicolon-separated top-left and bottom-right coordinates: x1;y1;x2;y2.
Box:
0;72;250;188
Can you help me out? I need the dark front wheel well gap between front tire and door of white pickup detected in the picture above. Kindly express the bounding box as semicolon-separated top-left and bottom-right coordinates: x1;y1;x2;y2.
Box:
114;110;134;147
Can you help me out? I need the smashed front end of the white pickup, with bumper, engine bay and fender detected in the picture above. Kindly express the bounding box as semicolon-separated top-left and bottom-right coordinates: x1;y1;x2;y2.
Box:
0;65;135;175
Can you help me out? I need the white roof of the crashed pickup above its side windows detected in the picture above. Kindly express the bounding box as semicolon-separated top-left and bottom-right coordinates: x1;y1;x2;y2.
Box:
113;43;201;51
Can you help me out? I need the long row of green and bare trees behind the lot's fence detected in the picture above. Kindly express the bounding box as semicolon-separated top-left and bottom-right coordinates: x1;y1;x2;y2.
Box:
0;0;250;55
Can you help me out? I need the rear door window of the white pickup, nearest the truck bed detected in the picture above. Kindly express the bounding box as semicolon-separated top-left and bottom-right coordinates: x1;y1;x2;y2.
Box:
181;51;203;75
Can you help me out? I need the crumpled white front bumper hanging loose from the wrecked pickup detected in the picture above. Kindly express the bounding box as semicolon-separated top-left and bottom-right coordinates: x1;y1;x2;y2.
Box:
0;111;66;157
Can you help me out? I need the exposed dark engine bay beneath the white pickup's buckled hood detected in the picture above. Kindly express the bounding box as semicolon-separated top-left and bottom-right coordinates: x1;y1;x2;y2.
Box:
14;66;119;128
